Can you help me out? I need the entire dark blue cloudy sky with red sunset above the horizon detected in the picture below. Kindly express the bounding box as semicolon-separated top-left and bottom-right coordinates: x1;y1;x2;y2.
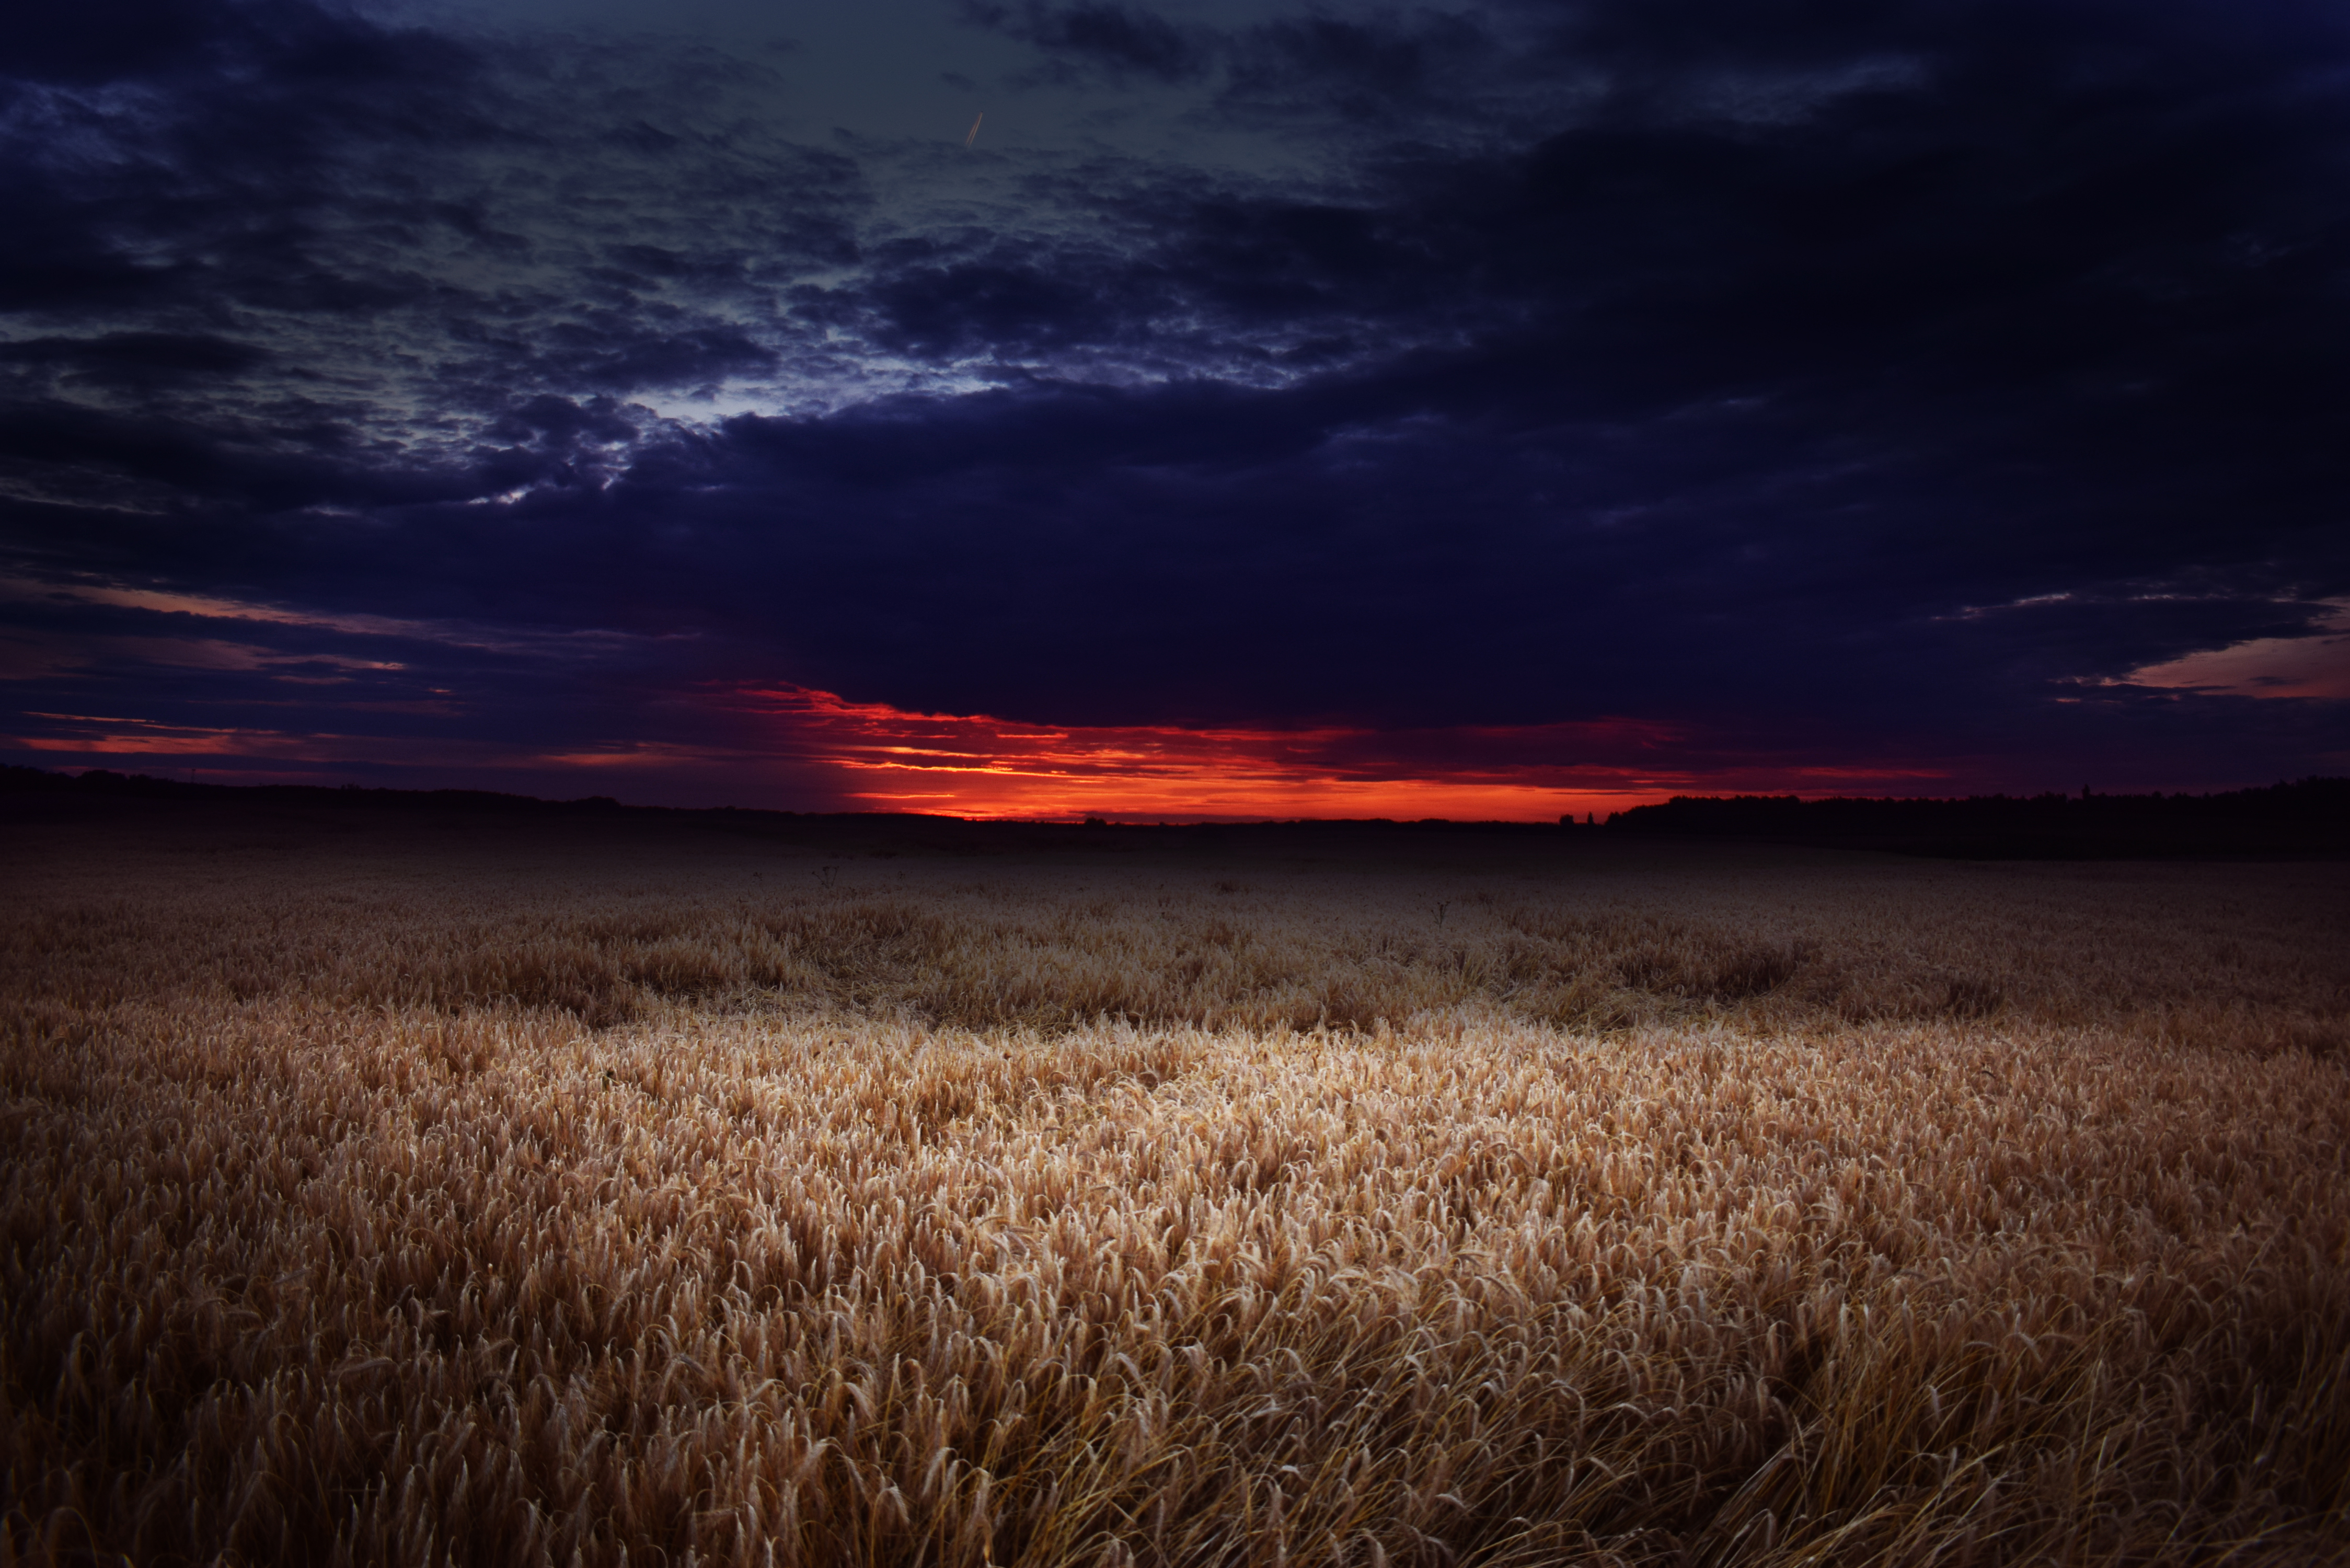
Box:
0;0;2350;821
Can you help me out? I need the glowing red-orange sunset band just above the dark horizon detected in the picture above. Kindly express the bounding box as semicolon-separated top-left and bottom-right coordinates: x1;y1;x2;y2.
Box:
7;686;1939;821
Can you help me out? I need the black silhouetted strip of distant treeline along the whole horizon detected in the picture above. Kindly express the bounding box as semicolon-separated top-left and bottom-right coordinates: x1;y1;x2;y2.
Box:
0;766;2350;860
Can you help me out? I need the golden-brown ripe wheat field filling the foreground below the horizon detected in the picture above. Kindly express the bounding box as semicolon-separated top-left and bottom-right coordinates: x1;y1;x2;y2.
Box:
0;816;2350;1568
